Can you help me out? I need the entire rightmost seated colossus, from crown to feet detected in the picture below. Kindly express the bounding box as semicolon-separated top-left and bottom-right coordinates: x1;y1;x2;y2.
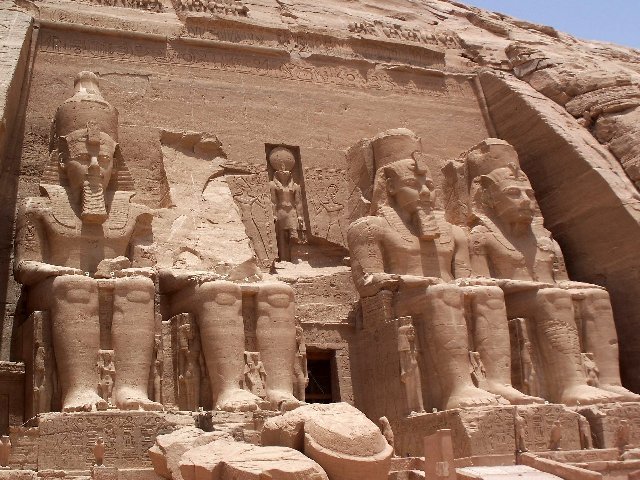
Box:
466;139;639;405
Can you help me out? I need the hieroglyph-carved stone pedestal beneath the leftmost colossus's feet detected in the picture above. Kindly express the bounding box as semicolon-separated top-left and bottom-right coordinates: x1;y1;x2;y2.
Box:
38;412;194;470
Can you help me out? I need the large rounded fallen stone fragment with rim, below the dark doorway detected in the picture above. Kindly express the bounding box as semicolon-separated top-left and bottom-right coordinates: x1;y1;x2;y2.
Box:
262;403;393;480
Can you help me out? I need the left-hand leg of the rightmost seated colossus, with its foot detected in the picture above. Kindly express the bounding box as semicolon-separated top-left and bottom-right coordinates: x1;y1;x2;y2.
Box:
533;288;620;405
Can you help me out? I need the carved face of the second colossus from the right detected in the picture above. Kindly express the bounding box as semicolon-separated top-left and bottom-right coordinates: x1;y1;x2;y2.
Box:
387;162;436;213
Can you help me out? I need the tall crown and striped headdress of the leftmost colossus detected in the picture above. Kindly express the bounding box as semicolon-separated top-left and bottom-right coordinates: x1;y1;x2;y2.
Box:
40;71;134;191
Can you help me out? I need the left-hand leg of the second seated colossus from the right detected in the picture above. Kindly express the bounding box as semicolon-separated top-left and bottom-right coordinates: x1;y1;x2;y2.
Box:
424;285;508;409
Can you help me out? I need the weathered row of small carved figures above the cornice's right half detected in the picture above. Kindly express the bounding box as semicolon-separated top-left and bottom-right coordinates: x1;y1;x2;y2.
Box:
348;20;462;48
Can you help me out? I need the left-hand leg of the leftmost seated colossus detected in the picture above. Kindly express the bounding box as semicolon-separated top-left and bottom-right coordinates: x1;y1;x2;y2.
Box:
48;275;107;412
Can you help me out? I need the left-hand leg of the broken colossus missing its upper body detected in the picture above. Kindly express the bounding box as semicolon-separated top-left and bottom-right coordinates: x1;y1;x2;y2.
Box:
194;281;262;411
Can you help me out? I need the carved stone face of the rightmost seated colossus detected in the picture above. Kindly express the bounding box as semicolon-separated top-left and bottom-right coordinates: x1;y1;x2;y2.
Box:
489;177;535;223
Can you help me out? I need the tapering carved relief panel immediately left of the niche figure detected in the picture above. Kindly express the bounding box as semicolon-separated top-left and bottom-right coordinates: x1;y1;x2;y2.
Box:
226;172;278;269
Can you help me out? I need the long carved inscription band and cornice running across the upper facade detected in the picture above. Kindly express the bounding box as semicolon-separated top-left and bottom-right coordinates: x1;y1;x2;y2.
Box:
40;30;475;98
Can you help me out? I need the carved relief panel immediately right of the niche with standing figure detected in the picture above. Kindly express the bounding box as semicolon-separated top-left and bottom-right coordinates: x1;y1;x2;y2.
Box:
304;168;348;248
